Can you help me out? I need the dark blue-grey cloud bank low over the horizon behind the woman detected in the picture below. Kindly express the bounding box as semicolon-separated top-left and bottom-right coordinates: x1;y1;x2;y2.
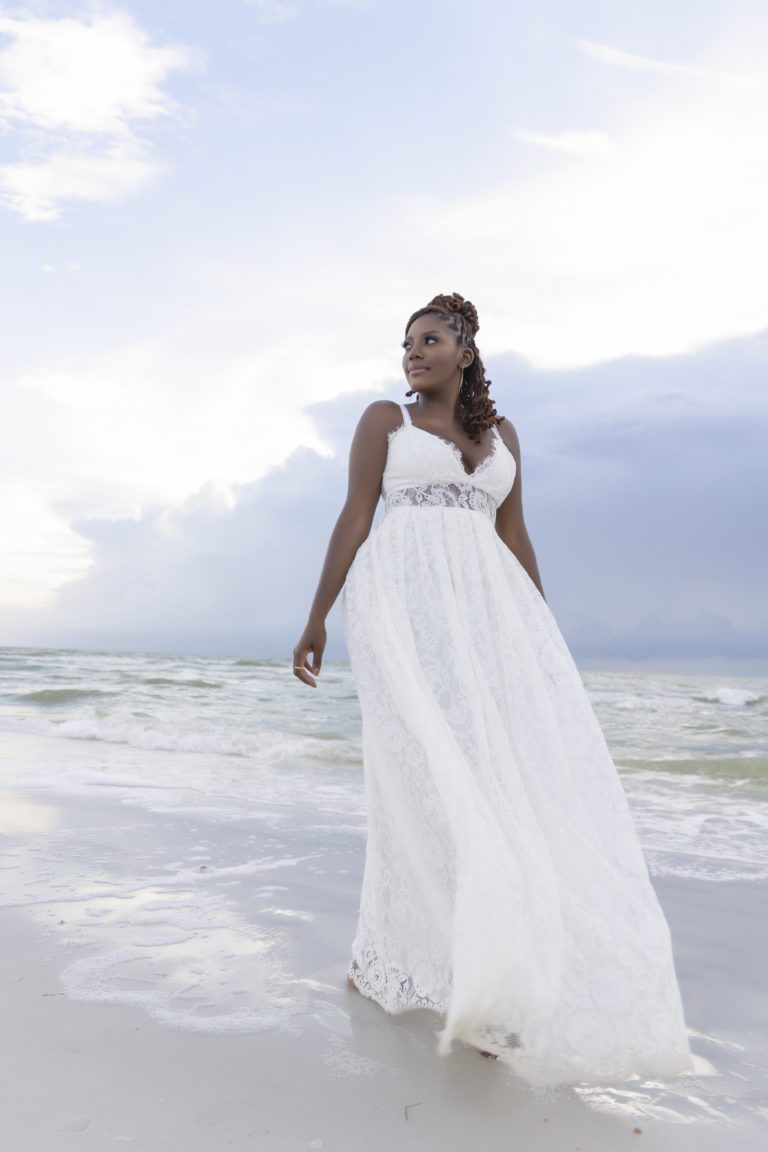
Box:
9;332;768;661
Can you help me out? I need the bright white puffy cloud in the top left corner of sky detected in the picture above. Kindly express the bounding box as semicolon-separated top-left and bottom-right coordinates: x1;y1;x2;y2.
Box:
0;10;196;221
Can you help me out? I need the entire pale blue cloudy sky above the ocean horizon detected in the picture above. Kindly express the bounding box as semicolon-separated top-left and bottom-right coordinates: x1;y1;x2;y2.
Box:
0;0;768;673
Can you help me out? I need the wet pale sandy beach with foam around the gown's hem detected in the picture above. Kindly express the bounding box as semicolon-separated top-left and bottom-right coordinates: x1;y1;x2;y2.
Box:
0;789;768;1152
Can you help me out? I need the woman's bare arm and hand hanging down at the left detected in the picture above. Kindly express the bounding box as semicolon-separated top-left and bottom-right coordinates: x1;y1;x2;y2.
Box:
294;400;402;688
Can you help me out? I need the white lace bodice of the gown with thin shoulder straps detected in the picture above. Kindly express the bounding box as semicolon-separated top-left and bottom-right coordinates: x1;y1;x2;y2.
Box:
381;404;517;518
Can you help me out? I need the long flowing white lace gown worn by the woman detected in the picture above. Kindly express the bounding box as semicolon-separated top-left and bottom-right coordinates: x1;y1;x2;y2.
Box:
342;406;692;1085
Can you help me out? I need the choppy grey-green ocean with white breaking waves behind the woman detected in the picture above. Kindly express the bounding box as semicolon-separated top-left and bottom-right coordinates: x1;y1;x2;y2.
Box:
0;647;768;882
